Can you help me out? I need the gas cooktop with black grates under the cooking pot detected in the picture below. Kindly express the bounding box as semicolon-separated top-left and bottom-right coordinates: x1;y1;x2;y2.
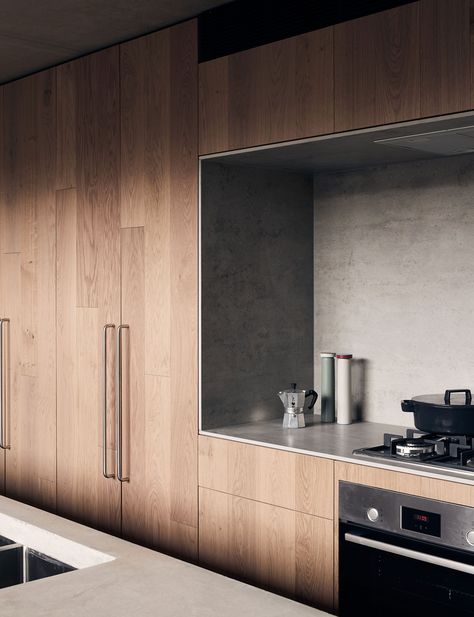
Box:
353;429;474;475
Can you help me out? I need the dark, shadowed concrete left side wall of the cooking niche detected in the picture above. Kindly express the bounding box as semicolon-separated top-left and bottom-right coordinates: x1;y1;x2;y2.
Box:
201;162;314;429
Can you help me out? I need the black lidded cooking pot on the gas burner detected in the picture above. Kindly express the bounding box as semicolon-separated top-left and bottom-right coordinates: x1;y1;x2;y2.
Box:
402;390;474;436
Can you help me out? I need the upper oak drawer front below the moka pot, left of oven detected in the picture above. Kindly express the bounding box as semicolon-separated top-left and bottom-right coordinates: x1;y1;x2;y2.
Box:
199;436;334;519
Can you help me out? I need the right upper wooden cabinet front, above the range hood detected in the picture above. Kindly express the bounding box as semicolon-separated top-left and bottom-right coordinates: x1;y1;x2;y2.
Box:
334;0;473;131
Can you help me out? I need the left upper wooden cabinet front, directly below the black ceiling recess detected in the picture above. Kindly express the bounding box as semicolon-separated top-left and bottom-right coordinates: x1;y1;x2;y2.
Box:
199;28;334;154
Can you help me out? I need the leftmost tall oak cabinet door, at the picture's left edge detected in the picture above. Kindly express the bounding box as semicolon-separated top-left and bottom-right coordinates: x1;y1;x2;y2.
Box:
0;70;56;509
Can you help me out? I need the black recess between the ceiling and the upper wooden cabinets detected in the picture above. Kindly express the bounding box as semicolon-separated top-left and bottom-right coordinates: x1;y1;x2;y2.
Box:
199;0;415;62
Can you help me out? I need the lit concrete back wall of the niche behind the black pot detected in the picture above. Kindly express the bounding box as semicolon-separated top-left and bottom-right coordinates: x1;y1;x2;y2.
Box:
314;155;474;426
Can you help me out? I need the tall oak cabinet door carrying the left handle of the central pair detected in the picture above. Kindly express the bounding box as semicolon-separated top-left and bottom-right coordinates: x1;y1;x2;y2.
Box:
56;47;121;533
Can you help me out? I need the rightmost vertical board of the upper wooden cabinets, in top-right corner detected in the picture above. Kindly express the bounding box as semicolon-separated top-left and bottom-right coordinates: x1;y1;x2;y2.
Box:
420;0;471;116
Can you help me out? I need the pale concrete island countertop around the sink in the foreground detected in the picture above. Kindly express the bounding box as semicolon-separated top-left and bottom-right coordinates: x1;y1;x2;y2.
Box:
0;497;327;617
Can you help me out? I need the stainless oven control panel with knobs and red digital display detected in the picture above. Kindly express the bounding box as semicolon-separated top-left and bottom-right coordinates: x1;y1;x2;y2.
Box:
339;481;474;552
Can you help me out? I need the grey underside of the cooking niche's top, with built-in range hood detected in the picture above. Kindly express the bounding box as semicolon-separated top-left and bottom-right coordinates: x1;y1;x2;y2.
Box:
201;111;474;173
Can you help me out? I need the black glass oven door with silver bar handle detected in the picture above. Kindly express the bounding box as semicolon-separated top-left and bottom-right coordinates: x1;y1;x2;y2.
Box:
339;522;474;617
